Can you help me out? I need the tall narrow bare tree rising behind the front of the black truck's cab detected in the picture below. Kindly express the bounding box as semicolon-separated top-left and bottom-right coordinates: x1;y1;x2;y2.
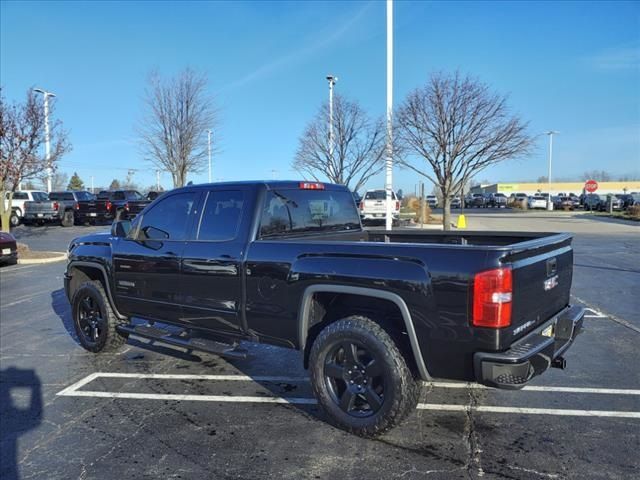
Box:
137;69;217;187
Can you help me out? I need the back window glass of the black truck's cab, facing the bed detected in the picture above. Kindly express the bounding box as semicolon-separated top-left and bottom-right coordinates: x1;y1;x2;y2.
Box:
260;190;360;237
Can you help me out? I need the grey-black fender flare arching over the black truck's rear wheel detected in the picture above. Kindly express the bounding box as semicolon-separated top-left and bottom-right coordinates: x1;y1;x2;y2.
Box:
298;284;432;381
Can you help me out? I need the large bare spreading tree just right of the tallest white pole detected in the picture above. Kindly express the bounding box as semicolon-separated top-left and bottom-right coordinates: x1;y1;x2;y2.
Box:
395;73;533;230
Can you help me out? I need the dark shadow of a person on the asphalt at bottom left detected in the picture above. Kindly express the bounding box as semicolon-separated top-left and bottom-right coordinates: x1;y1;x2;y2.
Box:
0;367;42;480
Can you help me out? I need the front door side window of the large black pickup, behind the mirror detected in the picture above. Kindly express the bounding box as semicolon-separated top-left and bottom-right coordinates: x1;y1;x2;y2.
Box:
137;192;196;240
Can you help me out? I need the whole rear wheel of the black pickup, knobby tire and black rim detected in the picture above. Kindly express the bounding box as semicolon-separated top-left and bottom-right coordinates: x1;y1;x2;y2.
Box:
310;316;420;437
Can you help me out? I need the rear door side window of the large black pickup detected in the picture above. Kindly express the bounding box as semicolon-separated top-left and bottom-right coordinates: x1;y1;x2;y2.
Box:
198;190;244;241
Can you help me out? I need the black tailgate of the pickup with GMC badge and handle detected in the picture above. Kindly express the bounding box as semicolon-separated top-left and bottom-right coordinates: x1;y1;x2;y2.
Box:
504;234;573;338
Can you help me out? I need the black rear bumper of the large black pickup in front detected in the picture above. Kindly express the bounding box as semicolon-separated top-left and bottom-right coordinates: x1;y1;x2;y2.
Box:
473;306;584;389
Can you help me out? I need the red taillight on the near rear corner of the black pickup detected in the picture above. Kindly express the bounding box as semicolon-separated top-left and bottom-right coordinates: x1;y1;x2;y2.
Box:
473;268;513;328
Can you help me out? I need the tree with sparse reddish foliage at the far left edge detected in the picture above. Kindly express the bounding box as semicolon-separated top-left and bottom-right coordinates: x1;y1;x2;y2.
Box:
0;89;71;231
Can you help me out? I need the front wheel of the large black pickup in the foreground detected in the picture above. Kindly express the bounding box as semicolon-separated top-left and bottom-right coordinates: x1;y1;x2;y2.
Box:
71;280;126;353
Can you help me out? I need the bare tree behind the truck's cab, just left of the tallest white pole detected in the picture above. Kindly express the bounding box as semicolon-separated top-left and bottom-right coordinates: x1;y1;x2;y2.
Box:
293;95;385;191
